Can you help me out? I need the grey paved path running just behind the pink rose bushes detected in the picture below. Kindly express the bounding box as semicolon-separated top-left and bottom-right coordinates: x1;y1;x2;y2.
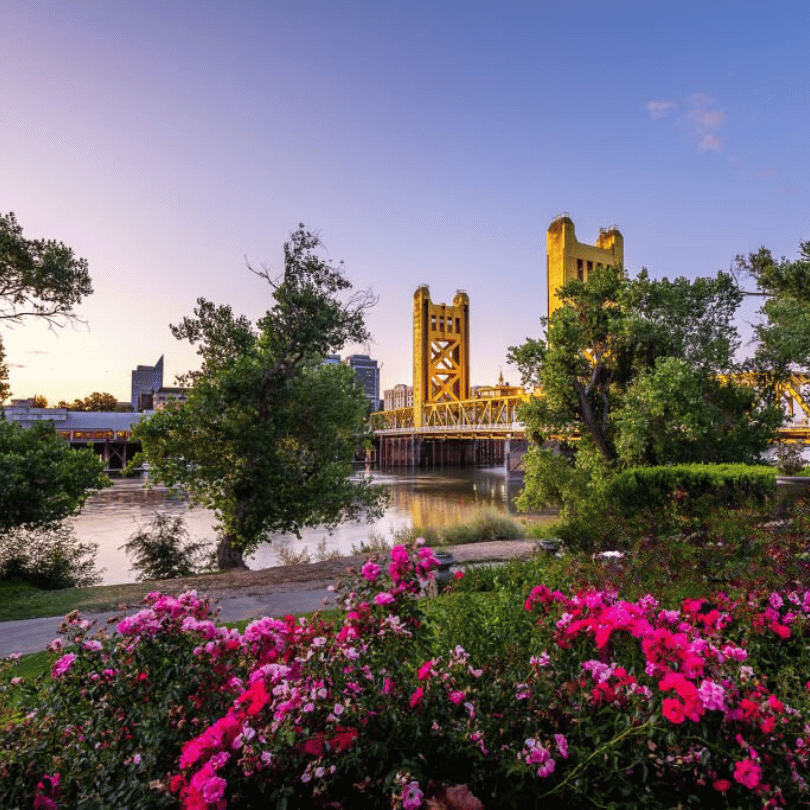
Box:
0;587;334;658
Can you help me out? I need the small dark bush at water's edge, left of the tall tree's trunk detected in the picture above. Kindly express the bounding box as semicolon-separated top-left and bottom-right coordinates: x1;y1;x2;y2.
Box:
121;512;208;581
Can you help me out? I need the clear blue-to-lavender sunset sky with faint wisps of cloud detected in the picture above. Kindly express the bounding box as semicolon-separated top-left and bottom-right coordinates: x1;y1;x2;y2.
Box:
0;0;810;403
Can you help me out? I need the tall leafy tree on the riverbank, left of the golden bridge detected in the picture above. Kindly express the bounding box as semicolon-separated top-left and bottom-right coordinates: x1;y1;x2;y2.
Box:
135;226;380;568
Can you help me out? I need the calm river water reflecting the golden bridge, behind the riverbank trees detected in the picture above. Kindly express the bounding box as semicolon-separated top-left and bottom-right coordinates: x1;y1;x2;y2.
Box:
72;468;536;585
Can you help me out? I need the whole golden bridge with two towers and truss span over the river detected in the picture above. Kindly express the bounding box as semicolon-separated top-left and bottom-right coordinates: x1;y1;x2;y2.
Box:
371;214;810;474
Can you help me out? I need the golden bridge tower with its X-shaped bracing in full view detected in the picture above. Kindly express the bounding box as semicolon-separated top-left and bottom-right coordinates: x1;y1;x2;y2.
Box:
413;284;470;427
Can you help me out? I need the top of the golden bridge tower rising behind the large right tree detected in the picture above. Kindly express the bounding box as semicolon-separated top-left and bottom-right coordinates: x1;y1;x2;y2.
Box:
546;214;624;315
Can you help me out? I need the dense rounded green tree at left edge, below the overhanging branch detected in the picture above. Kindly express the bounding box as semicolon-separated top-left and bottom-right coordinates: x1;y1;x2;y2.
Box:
0;419;109;532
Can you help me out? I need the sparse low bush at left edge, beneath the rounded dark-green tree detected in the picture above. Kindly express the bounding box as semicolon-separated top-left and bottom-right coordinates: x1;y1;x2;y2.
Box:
0;522;101;590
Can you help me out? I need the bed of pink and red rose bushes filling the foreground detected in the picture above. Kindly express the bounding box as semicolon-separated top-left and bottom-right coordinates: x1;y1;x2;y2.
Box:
0;546;810;810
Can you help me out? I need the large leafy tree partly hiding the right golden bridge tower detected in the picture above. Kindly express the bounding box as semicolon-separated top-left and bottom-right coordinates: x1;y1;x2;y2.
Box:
509;267;780;506
